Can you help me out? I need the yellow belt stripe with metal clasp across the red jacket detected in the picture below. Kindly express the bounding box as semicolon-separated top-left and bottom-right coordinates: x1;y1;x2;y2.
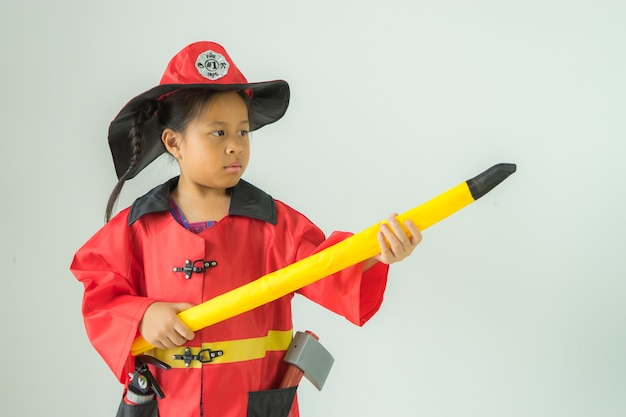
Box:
151;330;293;368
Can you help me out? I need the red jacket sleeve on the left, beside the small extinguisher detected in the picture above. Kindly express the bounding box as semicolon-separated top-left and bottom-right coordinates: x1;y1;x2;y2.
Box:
70;210;154;383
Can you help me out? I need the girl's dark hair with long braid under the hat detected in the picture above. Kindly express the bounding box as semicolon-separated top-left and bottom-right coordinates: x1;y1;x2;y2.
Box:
105;88;250;222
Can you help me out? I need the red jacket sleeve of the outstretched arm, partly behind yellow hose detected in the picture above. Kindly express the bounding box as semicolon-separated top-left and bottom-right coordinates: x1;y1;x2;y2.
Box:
290;216;389;326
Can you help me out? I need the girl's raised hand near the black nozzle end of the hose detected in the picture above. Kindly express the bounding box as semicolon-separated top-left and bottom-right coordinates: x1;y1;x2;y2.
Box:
374;213;422;264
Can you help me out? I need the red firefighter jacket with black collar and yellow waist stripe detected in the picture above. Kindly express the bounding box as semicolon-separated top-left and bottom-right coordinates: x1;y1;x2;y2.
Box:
71;178;388;417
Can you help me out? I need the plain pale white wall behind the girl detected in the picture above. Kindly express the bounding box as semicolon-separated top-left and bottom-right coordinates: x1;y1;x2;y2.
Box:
0;0;626;417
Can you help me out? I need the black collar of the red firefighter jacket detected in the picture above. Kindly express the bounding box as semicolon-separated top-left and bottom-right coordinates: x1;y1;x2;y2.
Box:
128;177;276;226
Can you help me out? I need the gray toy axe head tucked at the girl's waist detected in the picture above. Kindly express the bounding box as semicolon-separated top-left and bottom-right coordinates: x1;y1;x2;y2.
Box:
285;332;335;390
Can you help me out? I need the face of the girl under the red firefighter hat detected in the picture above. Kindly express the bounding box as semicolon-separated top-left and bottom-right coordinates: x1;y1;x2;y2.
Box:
176;92;250;189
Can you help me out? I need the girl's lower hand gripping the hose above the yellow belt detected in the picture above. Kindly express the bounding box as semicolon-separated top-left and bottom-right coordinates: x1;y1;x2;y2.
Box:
139;302;195;349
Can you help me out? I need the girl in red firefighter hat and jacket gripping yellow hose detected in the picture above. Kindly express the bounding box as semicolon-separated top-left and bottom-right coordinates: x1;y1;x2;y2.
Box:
71;42;421;417
